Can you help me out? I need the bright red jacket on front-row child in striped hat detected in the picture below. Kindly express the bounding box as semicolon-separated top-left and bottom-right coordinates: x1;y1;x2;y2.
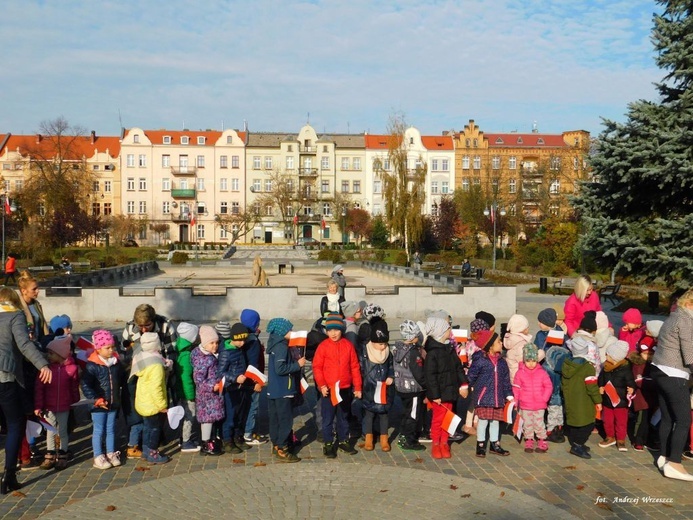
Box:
313;337;362;392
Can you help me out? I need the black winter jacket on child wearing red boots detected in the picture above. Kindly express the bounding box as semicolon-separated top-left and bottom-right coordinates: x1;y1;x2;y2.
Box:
424;338;469;403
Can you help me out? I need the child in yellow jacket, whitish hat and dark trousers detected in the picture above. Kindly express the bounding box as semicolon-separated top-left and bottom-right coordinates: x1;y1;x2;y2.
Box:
130;332;172;464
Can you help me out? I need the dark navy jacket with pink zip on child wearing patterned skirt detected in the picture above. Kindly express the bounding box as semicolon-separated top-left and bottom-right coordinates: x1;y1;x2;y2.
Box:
468;350;513;408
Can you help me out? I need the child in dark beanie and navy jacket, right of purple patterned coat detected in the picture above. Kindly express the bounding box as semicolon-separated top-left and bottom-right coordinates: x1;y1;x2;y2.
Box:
217;323;250;453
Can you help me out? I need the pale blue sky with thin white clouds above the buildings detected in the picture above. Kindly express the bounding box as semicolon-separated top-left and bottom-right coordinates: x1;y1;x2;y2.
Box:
0;0;664;136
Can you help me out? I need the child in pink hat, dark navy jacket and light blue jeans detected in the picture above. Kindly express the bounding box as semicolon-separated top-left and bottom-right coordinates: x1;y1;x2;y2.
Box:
82;329;124;469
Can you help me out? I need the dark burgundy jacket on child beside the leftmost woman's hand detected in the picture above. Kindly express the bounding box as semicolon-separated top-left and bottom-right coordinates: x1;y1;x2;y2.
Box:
34;356;79;412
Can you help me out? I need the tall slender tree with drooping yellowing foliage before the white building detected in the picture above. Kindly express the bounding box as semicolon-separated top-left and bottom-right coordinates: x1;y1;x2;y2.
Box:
375;115;427;263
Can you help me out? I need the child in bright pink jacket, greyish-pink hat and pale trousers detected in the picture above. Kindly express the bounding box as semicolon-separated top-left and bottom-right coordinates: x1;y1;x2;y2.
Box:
513;343;553;453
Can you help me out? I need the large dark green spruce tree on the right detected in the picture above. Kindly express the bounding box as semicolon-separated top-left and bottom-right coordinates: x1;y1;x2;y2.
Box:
574;0;693;285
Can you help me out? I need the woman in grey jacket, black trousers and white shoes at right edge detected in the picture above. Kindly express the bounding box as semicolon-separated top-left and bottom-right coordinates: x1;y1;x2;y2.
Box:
651;289;693;482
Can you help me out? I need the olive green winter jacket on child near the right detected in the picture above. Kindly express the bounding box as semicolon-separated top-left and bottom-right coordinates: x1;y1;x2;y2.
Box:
561;358;602;428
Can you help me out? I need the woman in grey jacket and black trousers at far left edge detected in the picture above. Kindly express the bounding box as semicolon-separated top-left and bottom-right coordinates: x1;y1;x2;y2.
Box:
0;287;51;495
